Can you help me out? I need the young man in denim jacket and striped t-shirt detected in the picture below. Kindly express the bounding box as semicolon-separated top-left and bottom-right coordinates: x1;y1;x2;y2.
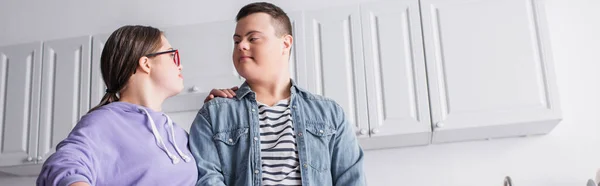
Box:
190;3;365;186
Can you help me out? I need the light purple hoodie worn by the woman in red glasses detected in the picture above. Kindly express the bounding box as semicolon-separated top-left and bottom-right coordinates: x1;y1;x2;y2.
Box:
37;102;198;186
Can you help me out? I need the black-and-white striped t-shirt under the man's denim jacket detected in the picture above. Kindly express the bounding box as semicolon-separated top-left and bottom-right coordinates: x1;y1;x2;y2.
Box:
258;99;302;186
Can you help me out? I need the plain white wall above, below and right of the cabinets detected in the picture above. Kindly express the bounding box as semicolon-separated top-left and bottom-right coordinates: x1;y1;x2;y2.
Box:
0;0;600;186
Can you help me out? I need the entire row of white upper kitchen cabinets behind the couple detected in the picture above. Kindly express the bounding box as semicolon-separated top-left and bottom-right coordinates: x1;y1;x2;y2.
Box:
0;0;561;172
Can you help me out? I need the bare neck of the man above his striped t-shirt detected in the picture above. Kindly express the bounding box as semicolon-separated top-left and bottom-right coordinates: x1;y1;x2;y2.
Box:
248;77;292;106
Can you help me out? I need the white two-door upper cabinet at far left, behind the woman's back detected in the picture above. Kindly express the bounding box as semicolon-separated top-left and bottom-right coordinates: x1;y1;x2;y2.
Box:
0;36;91;175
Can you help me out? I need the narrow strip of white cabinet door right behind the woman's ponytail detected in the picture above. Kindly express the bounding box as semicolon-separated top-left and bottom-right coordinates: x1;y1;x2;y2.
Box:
89;34;110;109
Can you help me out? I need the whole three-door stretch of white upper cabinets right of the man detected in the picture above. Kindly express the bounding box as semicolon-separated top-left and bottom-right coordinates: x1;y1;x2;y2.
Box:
304;0;561;149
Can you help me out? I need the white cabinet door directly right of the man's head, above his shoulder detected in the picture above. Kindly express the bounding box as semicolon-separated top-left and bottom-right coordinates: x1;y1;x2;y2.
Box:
305;5;369;137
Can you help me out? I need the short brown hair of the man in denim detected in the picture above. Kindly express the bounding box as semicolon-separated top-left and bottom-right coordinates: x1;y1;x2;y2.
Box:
235;2;292;37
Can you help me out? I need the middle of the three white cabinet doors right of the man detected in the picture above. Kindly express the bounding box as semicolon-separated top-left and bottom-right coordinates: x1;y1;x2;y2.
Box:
361;0;431;147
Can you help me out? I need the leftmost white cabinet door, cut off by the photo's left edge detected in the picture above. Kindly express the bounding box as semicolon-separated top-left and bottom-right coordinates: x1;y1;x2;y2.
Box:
0;42;42;166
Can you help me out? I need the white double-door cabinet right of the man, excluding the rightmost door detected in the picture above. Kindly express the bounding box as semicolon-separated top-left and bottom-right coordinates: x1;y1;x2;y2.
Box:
305;1;431;149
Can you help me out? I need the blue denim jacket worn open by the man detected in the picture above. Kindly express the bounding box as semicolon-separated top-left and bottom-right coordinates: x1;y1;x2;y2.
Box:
189;81;365;186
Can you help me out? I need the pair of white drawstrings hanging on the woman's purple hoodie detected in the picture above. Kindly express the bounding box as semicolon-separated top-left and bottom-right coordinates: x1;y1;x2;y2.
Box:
139;108;191;164
